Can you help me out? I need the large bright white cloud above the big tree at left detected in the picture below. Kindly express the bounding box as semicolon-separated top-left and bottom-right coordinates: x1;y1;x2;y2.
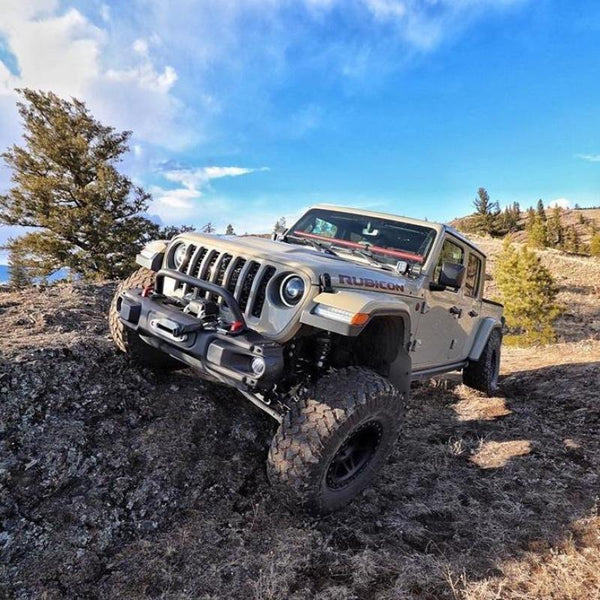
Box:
0;0;190;150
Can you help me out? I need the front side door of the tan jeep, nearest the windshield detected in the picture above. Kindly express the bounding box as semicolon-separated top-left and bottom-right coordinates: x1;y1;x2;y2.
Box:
413;236;466;369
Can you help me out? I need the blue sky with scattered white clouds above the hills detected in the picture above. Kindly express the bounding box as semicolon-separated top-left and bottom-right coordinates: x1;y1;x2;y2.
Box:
0;0;600;258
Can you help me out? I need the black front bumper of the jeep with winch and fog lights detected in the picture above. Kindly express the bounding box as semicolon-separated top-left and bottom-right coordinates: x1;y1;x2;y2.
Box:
119;271;284;389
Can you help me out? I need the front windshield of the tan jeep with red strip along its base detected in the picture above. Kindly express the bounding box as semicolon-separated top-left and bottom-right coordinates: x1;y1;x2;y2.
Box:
286;209;435;265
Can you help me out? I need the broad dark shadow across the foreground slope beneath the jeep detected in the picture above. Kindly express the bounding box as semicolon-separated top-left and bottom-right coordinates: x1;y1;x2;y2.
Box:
5;354;600;599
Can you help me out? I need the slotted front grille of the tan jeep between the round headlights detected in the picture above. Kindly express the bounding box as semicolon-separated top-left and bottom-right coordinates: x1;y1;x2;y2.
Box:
175;244;277;319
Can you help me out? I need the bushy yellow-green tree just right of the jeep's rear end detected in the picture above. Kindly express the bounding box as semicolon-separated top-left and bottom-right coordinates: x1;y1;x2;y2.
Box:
494;238;561;344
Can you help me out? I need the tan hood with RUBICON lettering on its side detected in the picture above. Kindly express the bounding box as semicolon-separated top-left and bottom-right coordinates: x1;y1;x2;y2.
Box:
178;233;423;296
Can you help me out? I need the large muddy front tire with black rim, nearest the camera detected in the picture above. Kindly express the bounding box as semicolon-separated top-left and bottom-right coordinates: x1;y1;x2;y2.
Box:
267;367;404;514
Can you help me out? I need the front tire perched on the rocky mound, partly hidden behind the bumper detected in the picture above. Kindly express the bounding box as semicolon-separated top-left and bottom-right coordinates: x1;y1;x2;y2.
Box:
108;268;185;372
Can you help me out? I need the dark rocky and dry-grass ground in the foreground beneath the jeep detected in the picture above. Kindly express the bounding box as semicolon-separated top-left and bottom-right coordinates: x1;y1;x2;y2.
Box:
0;285;600;600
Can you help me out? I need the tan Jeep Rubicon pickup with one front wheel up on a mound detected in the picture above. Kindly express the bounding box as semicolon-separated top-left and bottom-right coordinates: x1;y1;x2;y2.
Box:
110;205;503;513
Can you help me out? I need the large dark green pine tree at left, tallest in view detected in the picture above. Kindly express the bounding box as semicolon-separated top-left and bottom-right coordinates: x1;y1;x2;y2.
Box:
0;89;158;279
